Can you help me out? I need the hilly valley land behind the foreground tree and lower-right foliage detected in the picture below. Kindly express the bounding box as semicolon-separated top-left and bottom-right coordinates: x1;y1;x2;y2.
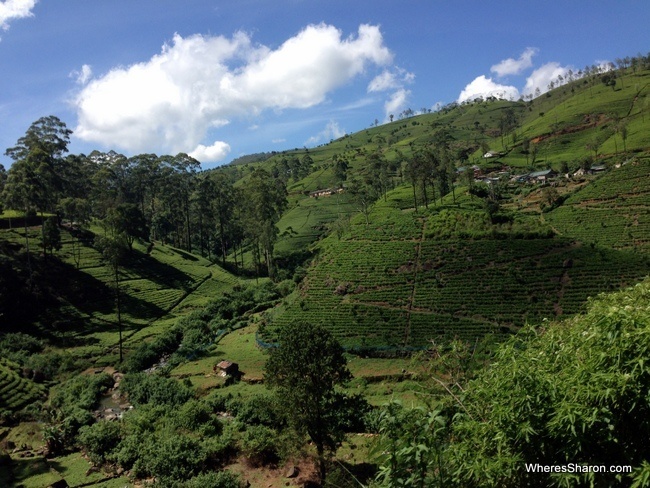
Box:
0;60;650;486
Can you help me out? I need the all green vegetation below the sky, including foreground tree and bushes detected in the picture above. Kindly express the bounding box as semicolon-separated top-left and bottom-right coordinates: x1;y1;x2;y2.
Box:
0;51;650;487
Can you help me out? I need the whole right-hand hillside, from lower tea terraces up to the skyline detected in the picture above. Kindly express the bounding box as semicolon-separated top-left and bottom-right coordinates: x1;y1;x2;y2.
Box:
253;66;650;350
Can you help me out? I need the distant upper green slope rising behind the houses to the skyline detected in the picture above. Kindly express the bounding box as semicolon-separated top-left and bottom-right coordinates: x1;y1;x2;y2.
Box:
240;69;650;260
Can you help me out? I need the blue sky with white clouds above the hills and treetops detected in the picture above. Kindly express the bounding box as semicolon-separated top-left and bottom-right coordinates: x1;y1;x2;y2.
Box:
0;0;650;168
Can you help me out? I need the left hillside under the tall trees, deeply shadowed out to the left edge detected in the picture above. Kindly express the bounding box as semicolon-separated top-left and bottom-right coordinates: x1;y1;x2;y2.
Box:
0;225;245;365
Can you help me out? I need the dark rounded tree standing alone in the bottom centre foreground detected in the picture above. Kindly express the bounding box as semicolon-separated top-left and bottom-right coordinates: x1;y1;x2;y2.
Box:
264;322;351;480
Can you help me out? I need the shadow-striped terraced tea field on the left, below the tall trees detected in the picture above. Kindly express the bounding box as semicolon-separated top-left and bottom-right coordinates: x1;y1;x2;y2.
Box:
0;228;246;363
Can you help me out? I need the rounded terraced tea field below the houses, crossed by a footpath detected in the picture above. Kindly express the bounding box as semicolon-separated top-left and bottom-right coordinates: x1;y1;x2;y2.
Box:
264;177;650;348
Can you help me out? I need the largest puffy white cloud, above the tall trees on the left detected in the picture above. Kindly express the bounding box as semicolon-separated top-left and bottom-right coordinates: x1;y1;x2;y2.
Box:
74;24;392;154
